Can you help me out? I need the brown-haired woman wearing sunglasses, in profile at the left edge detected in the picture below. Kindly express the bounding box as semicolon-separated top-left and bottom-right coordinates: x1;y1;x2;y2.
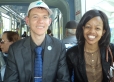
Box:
0;31;20;81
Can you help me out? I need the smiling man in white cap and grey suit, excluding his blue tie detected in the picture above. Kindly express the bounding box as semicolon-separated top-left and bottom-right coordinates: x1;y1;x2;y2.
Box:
4;1;69;82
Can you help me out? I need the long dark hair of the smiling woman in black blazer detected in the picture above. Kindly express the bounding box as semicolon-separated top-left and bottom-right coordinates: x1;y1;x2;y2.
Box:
76;9;111;47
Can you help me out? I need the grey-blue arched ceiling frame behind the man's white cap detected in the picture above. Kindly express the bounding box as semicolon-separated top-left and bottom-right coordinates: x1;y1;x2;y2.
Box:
0;0;70;28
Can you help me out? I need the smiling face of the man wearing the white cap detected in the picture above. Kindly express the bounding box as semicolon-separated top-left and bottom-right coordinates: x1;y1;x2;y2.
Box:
26;8;51;36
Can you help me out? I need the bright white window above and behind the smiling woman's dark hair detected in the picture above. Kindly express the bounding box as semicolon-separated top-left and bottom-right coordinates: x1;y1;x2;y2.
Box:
86;0;114;24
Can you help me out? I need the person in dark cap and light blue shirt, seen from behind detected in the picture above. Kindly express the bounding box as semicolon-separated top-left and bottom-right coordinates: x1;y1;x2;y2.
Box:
62;20;78;49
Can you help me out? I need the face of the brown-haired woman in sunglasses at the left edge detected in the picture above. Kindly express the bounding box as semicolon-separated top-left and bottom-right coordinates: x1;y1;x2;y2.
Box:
1;33;13;53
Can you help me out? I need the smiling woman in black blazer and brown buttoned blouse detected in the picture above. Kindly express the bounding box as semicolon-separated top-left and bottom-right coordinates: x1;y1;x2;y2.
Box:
66;10;114;82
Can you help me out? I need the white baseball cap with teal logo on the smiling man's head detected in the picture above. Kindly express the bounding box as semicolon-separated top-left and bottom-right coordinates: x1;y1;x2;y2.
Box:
27;1;52;16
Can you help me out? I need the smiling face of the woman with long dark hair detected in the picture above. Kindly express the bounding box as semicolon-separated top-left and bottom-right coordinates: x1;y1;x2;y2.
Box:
83;16;105;45
